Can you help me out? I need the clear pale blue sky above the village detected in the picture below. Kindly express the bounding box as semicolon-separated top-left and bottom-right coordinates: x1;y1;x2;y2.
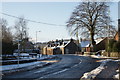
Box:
2;2;118;42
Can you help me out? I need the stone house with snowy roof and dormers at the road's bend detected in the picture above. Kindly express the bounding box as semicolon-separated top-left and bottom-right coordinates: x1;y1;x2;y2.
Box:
43;39;80;55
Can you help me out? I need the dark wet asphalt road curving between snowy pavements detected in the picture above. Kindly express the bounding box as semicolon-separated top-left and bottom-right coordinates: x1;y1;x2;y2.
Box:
2;55;100;80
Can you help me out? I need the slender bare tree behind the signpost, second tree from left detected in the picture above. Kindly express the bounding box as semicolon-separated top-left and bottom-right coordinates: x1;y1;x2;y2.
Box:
15;17;28;51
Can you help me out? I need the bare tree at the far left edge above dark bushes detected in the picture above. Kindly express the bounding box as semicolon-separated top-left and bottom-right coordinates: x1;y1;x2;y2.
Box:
0;18;14;54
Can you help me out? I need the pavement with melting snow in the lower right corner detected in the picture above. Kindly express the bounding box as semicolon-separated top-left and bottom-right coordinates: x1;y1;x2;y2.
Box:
81;55;120;80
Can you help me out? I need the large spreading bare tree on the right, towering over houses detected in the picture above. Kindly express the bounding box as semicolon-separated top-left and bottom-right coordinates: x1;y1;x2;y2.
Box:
67;2;114;50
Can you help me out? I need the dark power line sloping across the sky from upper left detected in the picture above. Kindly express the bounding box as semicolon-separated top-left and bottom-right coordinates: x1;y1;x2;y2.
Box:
0;12;65;26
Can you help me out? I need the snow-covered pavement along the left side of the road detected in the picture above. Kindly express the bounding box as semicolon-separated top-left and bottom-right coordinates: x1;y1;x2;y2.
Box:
0;56;60;75
